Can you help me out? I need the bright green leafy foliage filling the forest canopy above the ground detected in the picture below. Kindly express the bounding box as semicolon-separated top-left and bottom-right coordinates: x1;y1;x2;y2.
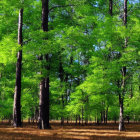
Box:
0;0;140;120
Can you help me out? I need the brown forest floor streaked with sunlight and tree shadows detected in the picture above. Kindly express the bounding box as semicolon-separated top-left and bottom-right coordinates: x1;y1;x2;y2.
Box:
0;122;140;140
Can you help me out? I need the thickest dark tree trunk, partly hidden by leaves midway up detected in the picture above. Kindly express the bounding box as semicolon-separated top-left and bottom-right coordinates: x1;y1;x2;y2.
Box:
39;0;50;129
